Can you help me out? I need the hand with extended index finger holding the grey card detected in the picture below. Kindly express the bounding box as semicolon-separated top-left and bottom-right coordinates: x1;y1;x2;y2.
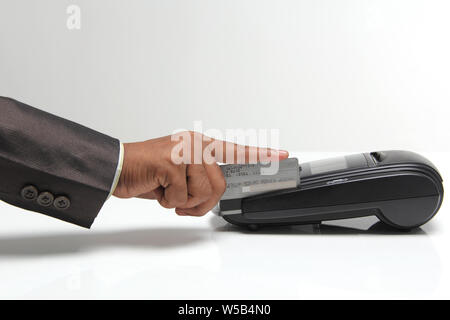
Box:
114;132;289;216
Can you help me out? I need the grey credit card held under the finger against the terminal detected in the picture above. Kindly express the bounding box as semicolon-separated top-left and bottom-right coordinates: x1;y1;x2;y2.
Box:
220;158;300;200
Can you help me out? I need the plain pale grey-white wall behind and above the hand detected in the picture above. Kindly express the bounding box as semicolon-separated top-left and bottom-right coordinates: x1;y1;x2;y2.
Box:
0;0;450;151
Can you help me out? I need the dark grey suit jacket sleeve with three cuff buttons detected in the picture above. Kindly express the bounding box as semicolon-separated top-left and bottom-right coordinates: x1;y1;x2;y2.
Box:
0;97;120;228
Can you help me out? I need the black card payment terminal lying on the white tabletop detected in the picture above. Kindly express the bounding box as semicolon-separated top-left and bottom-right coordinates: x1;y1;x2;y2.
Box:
217;151;444;229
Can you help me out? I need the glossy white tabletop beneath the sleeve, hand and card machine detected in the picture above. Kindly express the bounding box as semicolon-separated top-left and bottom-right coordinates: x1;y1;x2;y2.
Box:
0;153;450;299
